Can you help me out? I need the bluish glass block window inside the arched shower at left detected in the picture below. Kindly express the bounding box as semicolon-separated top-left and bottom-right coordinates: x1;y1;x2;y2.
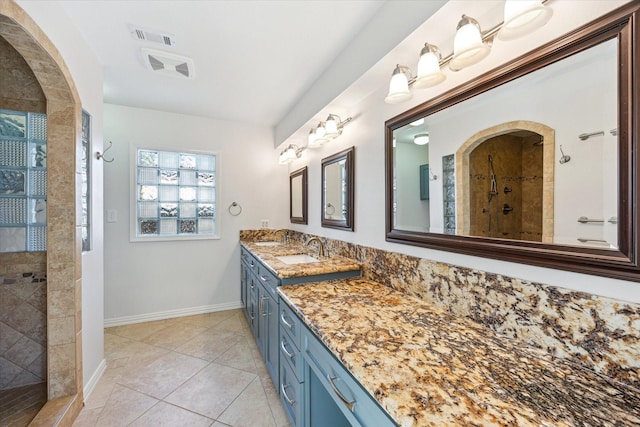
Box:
0;110;47;252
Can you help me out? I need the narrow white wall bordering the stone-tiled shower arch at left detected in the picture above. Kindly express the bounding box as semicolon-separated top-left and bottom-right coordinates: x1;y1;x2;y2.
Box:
17;0;104;391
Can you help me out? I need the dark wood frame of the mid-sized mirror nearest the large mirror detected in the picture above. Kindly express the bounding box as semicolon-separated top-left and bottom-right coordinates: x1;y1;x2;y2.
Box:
320;147;355;231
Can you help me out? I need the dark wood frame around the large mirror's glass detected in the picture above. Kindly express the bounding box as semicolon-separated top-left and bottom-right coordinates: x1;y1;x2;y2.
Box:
385;2;640;282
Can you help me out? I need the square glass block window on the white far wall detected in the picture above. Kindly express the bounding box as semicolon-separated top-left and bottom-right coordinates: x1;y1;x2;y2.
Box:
132;149;218;241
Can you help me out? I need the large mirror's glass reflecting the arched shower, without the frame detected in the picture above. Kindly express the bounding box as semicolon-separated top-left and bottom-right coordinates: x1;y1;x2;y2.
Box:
393;39;618;248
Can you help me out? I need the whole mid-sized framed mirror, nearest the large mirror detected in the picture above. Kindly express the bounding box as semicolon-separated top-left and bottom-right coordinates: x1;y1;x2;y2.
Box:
321;147;355;231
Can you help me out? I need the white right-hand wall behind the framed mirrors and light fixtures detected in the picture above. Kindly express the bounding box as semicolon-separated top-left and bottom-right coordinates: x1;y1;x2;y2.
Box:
290;1;640;303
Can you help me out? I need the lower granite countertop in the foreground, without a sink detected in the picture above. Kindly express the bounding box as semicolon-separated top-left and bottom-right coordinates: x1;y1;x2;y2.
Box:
278;278;640;426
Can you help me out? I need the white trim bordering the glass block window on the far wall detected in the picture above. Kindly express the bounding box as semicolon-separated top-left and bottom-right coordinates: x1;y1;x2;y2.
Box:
129;144;220;243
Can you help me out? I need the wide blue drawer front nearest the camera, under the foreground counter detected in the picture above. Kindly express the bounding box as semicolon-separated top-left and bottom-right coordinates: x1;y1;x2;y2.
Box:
303;328;397;427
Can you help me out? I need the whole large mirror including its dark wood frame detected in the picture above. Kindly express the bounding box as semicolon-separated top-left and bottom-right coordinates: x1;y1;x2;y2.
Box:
385;2;640;281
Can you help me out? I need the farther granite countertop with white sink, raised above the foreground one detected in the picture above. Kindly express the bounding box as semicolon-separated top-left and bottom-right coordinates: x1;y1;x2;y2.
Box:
240;241;361;279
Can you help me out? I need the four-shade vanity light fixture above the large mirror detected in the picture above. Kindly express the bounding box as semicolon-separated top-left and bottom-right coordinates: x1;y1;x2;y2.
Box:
384;0;553;104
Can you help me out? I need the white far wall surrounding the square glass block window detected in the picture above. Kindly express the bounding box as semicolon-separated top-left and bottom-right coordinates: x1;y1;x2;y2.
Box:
104;104;289;325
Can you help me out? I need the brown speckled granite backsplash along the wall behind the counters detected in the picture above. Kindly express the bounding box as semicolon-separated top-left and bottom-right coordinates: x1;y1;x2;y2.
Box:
240;229;640;387
